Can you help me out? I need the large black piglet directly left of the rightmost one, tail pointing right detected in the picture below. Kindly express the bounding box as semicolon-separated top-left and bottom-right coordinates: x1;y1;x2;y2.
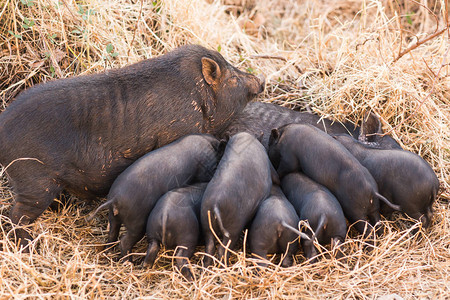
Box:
269;124;398;237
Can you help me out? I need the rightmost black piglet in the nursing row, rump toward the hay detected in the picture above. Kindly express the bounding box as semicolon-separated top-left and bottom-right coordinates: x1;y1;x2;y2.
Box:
334;135;439;228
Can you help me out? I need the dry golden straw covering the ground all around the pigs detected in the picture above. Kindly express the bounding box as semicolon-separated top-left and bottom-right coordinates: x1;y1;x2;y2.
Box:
0;0;450;299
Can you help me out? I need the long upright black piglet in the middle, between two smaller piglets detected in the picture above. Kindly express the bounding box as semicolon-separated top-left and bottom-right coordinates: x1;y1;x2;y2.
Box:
201;132;276;267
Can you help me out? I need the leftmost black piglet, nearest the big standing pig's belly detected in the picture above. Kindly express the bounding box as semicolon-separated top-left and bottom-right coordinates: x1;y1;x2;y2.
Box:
89;134;220;256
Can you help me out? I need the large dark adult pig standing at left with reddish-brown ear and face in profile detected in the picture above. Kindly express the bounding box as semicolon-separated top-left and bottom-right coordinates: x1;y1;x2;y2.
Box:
0;45;264;245
